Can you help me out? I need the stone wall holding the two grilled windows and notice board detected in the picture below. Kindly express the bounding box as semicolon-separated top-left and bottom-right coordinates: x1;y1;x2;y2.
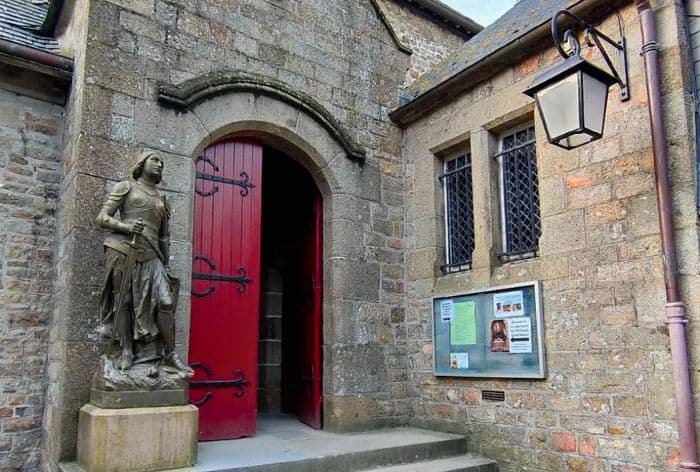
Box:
404;1;700;471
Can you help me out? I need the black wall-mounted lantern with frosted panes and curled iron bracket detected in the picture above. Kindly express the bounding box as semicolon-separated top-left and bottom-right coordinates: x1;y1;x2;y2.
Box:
524;10;629;149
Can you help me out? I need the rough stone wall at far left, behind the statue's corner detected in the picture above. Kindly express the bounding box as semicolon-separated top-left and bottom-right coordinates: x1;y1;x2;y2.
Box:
0;86;63;471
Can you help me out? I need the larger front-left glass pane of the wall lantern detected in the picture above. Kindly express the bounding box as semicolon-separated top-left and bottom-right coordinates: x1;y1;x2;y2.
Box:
537;73;581;141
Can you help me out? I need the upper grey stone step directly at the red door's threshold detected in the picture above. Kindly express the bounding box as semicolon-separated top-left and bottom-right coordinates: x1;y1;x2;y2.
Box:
194;428;470;472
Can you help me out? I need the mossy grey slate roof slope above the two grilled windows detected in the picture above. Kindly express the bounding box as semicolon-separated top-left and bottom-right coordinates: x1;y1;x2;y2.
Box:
401;0;584;105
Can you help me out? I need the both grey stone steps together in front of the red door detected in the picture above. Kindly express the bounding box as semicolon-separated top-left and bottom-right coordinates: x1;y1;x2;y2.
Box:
61;418;497;472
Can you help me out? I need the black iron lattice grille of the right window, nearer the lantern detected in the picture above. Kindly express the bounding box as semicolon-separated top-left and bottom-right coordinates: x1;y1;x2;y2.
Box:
496;126;542;261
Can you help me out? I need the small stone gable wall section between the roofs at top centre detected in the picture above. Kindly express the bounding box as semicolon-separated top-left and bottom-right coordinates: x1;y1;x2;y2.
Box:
377;0;469;84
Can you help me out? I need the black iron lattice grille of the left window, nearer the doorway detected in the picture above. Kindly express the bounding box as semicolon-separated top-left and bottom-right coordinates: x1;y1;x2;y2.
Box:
439;154;474;272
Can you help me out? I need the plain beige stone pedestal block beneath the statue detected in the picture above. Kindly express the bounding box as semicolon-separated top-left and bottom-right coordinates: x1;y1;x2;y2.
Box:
78;405;197;472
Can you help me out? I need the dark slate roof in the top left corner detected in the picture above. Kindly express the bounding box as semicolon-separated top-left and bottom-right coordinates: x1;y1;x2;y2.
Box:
0;0;59;53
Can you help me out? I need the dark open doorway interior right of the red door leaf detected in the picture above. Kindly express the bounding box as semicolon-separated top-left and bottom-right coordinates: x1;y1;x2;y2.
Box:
258;148;321;428
